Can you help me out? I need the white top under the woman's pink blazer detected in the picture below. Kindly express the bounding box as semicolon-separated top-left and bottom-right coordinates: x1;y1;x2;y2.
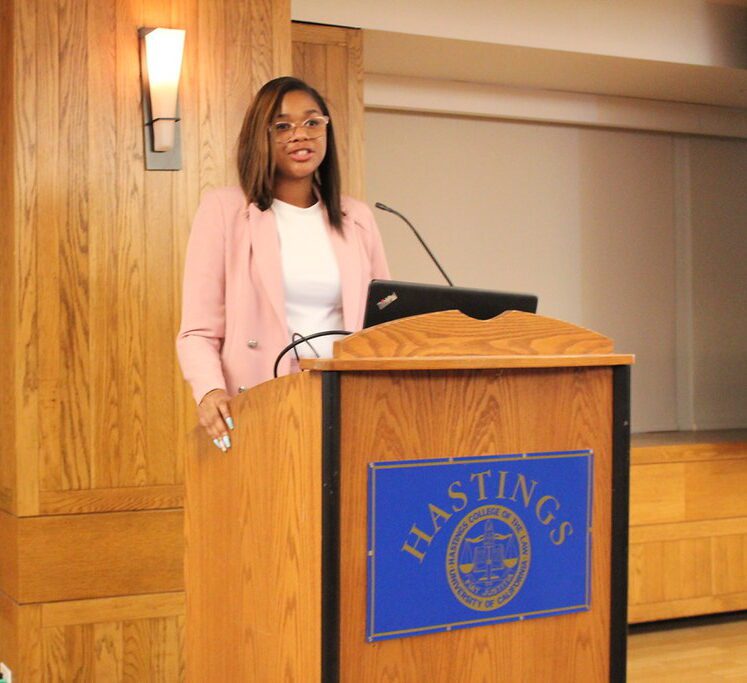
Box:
272;199;343;358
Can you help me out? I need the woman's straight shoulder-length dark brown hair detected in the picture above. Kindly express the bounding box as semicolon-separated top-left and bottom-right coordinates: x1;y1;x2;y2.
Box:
237;76;342;230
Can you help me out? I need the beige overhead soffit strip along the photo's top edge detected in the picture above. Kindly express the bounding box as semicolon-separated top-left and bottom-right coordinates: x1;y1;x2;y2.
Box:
291;0;747;68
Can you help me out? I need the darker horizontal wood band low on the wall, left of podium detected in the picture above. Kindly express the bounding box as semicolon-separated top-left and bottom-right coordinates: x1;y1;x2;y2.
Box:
10;510;184;603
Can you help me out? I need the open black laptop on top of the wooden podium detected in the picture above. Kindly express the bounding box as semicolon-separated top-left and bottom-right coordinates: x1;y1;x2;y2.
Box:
363;280;537;327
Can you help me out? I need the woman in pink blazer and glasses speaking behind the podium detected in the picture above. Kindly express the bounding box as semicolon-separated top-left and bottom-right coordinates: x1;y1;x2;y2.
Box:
177;77;389;451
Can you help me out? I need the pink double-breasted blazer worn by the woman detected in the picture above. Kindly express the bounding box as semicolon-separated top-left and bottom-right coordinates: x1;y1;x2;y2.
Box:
176;187;389;403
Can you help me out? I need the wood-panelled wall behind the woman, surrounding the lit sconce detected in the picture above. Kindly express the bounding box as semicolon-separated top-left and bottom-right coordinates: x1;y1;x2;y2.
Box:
0;0;291;682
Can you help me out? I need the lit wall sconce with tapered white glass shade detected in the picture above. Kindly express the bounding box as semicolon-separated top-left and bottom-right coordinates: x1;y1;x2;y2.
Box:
138;28;184;171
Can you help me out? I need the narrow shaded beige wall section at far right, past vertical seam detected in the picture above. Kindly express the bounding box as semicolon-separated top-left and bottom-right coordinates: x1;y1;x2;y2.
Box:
690;138;747;429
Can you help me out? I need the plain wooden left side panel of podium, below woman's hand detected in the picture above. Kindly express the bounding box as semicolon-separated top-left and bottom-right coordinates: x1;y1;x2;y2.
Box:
185;373;322;683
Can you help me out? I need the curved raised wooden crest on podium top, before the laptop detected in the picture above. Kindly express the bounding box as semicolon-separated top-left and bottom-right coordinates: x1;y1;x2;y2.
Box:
334;311;613;359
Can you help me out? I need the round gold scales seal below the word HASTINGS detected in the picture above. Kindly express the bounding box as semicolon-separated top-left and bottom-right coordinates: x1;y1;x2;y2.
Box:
446;505;531;612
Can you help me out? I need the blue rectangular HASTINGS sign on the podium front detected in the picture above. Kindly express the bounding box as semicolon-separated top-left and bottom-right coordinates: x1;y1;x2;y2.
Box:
366;450;593;641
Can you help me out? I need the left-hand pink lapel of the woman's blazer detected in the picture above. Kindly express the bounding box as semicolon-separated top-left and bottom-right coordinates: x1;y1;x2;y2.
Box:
249;204;288;330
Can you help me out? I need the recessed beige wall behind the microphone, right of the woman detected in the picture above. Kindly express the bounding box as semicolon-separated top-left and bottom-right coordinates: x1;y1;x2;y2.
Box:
366;111;747;431
